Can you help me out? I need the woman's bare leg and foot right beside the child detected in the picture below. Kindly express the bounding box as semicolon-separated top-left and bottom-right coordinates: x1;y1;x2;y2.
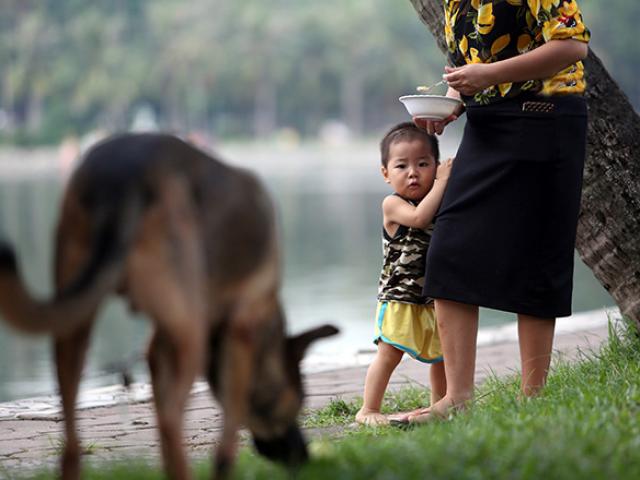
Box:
409;299;478;422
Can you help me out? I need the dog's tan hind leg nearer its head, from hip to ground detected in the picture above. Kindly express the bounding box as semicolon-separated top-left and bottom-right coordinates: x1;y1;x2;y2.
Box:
126;177;208;479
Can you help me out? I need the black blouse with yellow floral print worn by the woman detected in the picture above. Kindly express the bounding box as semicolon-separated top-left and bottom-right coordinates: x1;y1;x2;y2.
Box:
444;0;590;105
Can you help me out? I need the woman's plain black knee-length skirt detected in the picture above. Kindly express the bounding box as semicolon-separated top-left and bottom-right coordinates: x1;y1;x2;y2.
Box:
424;96;587;318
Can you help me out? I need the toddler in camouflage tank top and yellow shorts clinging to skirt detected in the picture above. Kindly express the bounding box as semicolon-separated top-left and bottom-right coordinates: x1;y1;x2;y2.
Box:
356;122;452;425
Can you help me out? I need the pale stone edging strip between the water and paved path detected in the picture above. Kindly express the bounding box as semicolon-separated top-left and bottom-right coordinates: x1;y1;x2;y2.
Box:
0;308;620;421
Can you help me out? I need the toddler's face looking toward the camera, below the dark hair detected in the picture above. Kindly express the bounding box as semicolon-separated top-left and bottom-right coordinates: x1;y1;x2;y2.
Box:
382;139;437;201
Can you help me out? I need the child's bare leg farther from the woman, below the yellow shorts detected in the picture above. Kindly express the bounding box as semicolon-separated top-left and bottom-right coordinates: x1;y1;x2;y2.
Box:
356;341;403;425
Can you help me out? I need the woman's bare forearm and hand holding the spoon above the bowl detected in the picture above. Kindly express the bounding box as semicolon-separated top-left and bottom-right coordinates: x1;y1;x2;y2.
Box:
443;39;588;95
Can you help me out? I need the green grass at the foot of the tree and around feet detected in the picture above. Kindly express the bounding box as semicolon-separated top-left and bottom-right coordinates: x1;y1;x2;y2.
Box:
11;318;640;480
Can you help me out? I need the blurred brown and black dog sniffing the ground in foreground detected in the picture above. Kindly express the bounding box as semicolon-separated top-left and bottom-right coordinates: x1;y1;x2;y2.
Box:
0;134;337;479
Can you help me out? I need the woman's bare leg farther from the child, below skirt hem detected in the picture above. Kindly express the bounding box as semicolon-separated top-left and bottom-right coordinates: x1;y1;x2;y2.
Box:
518;315;556;397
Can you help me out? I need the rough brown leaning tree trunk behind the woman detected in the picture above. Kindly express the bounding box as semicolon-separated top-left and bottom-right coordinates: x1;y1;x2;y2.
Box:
410;0;640;328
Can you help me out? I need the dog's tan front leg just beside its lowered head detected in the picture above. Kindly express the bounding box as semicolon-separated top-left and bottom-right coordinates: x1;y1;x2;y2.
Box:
213;321;254;480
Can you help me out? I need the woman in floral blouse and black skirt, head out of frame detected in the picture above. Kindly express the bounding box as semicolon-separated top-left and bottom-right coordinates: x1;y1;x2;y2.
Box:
405;0;589;422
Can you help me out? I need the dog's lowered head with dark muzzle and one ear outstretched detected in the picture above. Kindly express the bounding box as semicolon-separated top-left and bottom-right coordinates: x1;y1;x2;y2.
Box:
247;325;338;466
